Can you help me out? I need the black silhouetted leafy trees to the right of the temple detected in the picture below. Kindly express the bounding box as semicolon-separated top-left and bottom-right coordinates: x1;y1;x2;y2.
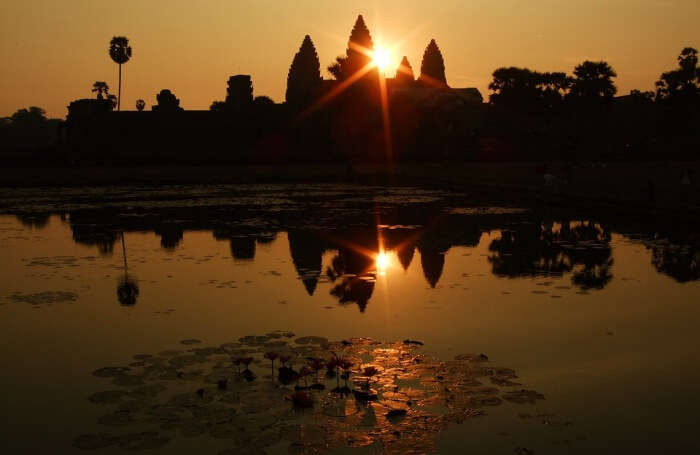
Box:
481;48;700;160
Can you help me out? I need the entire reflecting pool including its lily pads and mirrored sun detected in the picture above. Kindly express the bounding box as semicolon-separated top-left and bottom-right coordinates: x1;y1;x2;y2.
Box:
0;185;700;454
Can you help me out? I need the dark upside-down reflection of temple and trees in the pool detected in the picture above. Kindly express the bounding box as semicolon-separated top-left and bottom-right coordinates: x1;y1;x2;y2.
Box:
26;206;700;310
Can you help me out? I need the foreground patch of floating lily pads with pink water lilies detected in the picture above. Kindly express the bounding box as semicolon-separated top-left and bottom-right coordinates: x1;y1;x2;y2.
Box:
73;331;544;453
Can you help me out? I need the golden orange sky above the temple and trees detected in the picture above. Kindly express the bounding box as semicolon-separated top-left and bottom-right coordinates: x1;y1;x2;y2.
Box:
0;0;700;117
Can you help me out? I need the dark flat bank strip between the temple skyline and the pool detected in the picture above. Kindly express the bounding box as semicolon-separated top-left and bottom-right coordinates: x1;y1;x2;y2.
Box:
0;162;700;219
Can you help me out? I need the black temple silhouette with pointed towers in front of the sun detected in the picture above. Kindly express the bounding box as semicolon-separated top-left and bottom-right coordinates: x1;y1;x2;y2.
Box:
63;16;483;164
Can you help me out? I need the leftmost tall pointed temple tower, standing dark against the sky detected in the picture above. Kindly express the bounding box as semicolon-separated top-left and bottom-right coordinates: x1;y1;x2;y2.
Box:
285;35;322;107
